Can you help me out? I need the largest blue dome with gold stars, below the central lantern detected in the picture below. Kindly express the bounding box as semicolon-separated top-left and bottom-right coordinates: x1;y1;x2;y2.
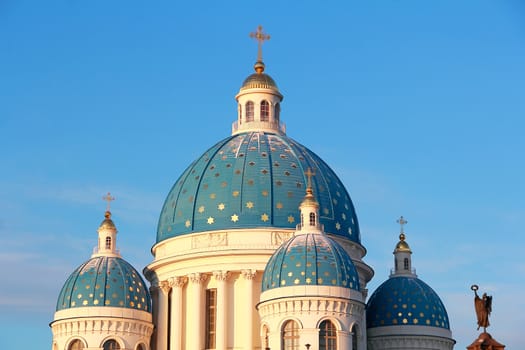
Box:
157;131;361;244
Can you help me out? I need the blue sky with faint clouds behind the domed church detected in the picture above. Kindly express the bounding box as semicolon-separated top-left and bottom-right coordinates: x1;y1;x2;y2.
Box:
0;0;525;349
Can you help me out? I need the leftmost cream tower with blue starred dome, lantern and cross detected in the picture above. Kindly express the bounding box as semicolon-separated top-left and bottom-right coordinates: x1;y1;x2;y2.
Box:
50;193;153;350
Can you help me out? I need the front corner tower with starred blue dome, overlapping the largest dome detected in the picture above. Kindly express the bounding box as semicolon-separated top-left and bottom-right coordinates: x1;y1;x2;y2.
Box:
257;175;366;350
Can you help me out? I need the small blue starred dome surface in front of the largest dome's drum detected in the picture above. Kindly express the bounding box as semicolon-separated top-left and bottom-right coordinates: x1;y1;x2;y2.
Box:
262;234;359;292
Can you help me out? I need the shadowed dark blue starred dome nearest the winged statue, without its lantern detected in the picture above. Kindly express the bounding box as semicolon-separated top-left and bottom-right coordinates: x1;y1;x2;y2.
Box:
366;276;450;330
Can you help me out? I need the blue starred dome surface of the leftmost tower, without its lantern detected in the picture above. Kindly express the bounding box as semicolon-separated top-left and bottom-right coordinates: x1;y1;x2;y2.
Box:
56;256;151;312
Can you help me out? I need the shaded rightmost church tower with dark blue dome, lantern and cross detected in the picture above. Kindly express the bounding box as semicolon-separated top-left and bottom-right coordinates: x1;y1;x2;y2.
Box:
366;216;455;350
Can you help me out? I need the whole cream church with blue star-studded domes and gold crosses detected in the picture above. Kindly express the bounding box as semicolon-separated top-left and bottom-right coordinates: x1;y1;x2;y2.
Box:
51;27;455;350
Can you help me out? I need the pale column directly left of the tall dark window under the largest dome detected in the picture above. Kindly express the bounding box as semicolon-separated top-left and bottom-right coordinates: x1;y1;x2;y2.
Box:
187;273;207;350
